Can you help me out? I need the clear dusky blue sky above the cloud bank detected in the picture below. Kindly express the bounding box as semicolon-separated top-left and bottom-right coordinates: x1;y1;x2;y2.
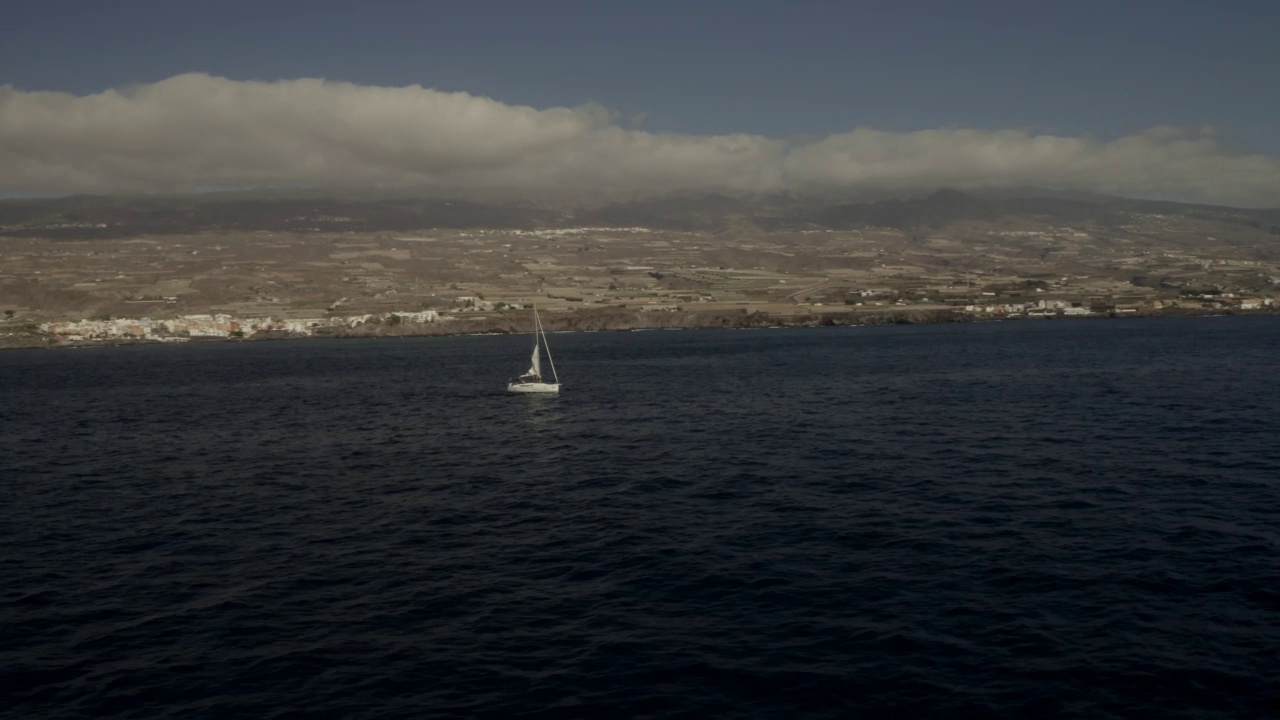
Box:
10;0;1280;148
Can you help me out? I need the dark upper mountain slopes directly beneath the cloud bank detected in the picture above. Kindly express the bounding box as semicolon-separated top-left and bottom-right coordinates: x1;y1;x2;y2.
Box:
0;188;1280;240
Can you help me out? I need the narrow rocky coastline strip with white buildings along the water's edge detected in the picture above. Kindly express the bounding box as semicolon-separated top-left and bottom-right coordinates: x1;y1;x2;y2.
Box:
0;302;1280;350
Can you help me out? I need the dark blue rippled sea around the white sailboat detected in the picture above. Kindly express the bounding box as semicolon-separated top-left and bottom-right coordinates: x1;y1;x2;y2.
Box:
0;318;1280;719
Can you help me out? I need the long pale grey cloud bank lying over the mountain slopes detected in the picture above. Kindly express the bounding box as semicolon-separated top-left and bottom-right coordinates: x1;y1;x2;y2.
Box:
0;74;1280;205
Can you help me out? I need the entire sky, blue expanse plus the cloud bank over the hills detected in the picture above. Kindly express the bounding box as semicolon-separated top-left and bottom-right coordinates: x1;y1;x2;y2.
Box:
0;0;1280;206
